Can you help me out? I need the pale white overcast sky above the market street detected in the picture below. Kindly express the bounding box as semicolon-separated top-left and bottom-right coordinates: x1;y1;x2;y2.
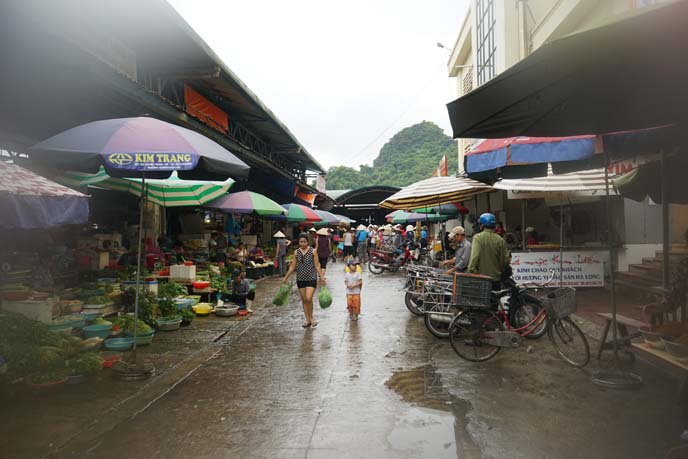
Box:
168;0;467;168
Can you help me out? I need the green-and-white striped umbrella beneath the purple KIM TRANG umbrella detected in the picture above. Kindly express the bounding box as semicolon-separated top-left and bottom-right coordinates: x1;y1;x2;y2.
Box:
58;166;234;207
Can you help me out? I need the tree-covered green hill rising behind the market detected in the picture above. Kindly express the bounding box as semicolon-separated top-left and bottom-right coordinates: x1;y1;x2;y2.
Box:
327;121;458;190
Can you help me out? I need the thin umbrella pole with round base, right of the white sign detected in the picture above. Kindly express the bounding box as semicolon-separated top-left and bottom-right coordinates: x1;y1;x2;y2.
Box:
592;151;643;389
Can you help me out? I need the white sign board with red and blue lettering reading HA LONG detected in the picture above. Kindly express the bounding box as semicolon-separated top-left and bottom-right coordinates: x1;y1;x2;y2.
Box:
511;251;606;287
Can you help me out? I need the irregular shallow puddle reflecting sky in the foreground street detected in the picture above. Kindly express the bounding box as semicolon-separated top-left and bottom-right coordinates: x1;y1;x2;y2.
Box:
385;365;482;459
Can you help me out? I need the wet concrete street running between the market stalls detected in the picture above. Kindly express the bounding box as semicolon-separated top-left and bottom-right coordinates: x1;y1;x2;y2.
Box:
0;264;681;458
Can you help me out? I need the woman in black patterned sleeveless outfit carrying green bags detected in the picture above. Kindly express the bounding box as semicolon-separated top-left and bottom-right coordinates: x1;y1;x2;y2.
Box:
283;233;326;328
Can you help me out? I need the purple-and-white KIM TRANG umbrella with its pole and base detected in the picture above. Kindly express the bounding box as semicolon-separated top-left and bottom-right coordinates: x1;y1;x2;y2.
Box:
29;117;249;375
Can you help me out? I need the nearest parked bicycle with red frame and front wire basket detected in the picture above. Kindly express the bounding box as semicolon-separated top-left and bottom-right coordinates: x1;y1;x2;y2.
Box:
449;279;590;368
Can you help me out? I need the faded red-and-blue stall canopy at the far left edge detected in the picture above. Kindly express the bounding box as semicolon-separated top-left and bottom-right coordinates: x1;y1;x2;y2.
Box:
0;161;88;229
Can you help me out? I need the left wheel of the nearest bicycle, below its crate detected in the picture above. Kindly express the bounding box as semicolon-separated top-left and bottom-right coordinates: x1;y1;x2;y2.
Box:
449;309;504;362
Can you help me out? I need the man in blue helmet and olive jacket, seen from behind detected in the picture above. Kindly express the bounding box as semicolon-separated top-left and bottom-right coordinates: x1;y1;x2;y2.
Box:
468;213;511;289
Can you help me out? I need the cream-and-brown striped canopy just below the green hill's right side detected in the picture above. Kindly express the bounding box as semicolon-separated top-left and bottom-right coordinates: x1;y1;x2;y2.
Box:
380;176;492;209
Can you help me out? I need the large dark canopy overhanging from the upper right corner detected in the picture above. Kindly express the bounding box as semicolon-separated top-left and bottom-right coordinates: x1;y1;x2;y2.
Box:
447;1;688;139
